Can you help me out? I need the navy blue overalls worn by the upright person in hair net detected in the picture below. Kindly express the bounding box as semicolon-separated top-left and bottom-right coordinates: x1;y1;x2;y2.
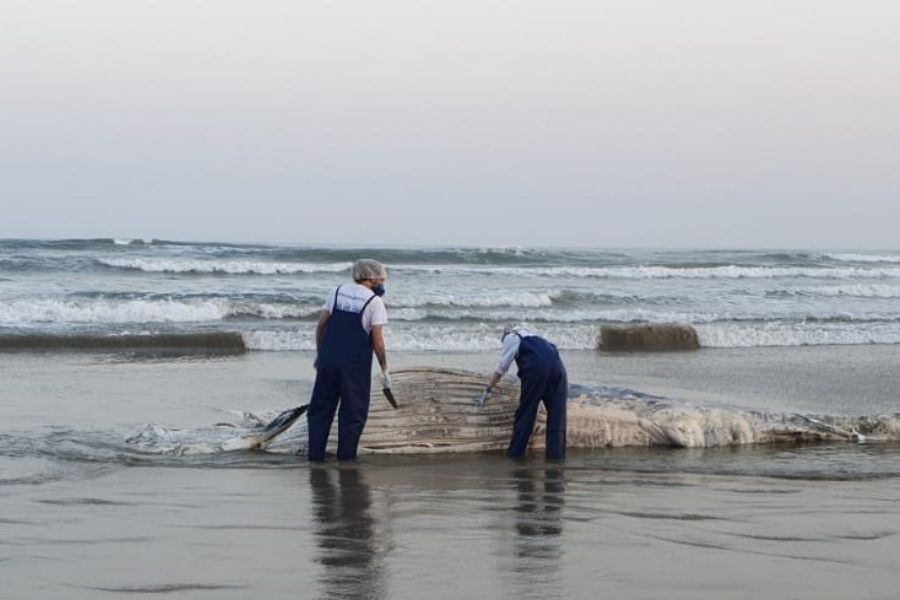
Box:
306;288;375;461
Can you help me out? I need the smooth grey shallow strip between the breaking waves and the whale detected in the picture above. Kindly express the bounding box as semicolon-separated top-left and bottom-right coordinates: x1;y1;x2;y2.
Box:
7;339;900;416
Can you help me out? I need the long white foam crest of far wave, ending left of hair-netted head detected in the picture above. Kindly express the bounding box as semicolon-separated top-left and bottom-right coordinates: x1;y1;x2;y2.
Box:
97;258;352;275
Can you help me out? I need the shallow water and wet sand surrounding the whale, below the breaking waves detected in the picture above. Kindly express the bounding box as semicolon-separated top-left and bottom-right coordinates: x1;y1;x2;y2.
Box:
0;347;900;599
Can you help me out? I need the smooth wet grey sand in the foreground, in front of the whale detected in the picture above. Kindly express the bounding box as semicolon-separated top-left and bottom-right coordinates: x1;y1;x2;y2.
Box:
0;455;900;599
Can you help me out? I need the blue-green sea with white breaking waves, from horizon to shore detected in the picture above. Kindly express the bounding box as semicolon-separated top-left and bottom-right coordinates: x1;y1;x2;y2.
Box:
0;239;900;352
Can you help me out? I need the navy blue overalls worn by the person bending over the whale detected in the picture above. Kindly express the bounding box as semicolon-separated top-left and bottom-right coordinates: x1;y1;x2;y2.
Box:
506;332;569;458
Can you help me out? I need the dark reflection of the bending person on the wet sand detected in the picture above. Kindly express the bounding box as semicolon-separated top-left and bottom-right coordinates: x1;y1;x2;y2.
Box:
512;467;565;597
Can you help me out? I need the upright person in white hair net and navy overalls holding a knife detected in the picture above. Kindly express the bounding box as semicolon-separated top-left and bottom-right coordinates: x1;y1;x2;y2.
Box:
307;259;391;461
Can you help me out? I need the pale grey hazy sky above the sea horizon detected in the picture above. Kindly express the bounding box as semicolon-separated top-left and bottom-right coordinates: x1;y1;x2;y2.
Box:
0;0;900;249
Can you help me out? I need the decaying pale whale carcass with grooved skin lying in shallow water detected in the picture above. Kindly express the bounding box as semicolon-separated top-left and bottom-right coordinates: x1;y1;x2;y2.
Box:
130;367;900;454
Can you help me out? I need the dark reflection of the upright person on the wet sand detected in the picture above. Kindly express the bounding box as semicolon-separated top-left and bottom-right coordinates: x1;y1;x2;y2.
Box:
309;466;387;600
